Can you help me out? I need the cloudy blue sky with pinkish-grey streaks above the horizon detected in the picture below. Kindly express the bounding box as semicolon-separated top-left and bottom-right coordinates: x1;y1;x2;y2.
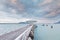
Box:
0;0;60;23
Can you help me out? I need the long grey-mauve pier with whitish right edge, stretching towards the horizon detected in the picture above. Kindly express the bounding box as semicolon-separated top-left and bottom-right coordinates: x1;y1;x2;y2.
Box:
0;25;33;40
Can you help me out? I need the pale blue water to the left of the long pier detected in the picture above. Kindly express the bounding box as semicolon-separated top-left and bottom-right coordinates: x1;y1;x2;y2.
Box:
0;24;28;35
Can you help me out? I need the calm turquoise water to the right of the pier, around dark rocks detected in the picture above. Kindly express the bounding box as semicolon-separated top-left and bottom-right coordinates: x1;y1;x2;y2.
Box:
34;24;60;40
